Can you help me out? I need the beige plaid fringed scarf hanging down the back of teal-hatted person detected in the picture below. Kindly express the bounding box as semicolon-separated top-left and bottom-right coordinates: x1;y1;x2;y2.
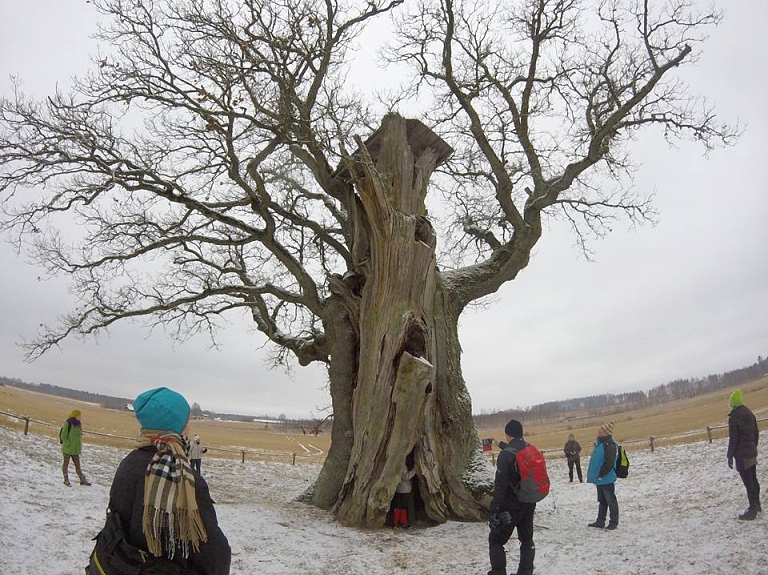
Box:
138;429;208;559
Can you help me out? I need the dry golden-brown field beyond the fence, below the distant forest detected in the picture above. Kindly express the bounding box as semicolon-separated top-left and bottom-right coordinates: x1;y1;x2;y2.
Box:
0;377;768;463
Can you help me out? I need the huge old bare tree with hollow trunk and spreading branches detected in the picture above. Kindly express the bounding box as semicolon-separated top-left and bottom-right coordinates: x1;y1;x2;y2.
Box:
0;0;734;526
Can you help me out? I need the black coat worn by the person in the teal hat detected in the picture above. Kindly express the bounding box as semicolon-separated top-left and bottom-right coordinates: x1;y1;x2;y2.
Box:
109;446;232;575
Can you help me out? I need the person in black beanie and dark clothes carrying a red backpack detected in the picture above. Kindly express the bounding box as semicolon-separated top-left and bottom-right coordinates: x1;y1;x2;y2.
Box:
488;419;549;575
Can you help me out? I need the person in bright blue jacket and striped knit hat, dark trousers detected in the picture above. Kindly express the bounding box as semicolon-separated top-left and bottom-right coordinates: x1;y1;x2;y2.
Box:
587;421;619;530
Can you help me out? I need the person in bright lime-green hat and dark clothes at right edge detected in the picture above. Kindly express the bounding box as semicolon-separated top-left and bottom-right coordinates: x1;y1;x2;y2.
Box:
728;389;763;521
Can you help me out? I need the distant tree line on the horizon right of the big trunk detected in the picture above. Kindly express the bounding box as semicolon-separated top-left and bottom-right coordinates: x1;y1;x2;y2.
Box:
474;356;768;429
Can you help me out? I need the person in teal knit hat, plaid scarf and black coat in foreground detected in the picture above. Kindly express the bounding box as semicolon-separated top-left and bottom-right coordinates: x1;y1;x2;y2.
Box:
88;387;232;575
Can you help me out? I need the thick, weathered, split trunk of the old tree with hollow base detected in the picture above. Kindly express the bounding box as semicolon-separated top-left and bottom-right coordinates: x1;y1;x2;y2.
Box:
313;114;490;527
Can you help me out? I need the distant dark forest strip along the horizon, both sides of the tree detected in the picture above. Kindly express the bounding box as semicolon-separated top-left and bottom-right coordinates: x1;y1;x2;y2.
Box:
0;356;768;428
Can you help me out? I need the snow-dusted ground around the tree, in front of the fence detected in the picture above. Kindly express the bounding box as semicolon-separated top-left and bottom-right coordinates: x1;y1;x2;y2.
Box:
0;428;768;575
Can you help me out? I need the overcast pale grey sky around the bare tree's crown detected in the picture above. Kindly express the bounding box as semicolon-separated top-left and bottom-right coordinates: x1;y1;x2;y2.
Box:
0;0;768;416
